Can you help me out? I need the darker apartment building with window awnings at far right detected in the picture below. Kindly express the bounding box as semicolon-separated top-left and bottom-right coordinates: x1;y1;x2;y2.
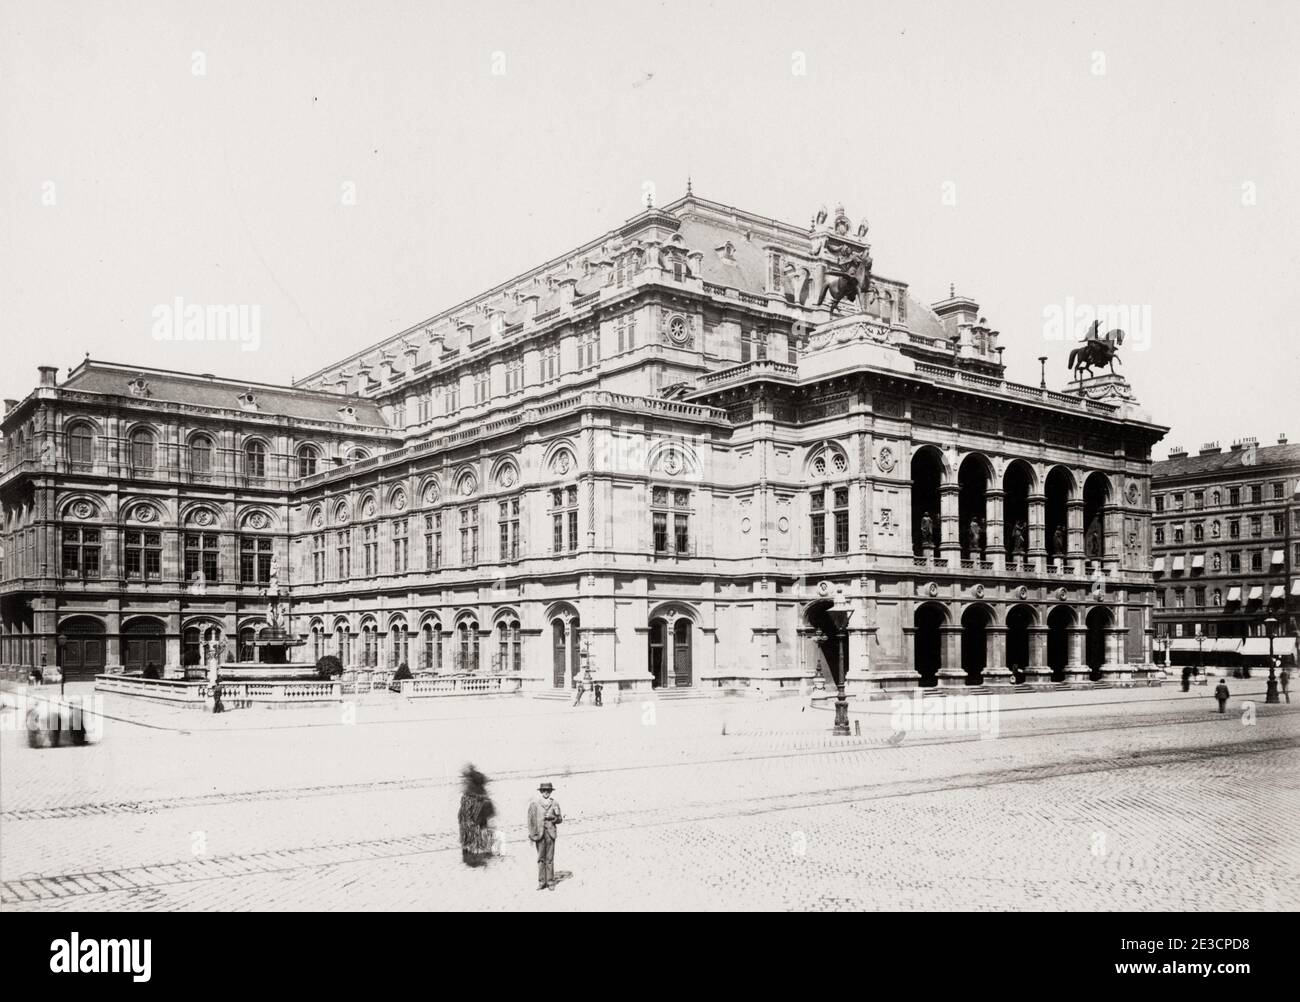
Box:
1152;437;1300;662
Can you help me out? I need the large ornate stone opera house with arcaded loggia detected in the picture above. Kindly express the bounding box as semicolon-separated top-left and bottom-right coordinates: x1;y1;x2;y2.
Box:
0;195;1165;694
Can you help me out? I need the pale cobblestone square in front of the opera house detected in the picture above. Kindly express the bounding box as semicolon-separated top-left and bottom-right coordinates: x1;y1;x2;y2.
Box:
0;682;1300;910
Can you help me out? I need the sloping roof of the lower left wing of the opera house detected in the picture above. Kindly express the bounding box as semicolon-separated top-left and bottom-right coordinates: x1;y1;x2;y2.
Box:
60;359;387;429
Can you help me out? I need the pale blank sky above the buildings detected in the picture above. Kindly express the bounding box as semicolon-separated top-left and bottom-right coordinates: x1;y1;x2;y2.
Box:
0;0;1300;456
